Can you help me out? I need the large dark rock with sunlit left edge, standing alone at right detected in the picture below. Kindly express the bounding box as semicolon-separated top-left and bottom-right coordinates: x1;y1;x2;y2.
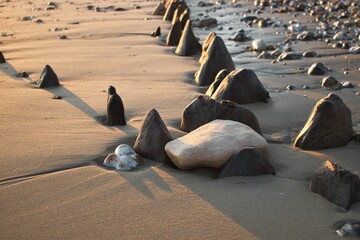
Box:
294;93;353;150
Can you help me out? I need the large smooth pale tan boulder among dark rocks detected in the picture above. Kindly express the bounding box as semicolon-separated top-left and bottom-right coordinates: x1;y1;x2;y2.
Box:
165;120;267;170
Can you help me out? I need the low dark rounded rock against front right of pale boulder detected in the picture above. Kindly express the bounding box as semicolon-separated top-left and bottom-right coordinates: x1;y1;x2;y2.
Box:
218;147;275;178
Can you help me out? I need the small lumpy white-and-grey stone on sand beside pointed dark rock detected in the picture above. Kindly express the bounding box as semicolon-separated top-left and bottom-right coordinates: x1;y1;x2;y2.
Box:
103;144;141;171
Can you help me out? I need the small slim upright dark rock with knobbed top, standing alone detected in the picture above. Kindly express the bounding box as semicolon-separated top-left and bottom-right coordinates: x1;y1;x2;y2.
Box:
107;86;126;126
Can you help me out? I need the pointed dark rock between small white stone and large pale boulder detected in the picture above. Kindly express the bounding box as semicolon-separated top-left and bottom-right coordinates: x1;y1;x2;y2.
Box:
134;109;173;162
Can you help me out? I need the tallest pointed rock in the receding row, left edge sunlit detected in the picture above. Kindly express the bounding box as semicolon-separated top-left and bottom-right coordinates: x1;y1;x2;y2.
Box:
195;36;235;86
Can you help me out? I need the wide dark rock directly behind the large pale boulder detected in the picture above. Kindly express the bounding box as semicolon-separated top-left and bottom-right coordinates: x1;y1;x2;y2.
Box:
180;96;261;135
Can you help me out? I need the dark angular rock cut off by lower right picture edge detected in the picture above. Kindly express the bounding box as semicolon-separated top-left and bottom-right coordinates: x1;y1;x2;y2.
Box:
310;161;360;210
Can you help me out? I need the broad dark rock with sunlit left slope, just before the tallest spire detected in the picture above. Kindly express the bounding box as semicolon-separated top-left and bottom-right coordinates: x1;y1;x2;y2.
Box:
211;69;270;104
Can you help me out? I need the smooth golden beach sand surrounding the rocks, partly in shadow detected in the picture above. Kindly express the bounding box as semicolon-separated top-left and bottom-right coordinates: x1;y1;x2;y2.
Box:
0;0;360;239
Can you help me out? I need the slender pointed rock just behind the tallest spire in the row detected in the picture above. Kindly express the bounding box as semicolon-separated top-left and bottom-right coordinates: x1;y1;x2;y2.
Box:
175;20;201;56
